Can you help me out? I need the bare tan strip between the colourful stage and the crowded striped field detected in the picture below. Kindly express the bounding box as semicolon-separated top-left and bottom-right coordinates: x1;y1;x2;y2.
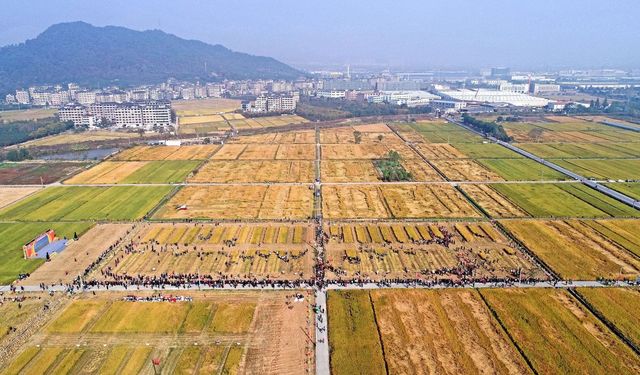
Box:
19;224;133;285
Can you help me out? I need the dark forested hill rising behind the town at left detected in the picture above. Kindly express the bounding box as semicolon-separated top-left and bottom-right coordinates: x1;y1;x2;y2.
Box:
0;22;303;93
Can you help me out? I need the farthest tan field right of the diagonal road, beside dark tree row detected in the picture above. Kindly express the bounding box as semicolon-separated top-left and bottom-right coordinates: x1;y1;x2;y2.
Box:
501;120;640;143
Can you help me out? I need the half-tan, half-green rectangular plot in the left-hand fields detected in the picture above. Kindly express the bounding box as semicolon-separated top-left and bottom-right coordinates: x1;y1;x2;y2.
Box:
65;160;200;184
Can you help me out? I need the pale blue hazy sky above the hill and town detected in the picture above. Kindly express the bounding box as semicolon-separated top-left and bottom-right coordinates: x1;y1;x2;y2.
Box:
0;0;640;69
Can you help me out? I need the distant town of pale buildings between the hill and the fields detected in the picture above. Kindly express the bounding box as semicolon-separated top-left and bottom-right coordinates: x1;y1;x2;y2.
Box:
4;66;640;132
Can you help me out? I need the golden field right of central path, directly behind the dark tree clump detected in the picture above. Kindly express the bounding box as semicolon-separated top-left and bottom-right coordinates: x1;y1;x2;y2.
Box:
321;143;418;160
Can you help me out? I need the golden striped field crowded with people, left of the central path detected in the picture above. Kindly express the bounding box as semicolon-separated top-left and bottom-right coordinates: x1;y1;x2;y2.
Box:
94;224;314;282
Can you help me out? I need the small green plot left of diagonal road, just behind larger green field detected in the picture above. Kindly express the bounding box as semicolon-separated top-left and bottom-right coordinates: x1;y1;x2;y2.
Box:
476;159;570;181
